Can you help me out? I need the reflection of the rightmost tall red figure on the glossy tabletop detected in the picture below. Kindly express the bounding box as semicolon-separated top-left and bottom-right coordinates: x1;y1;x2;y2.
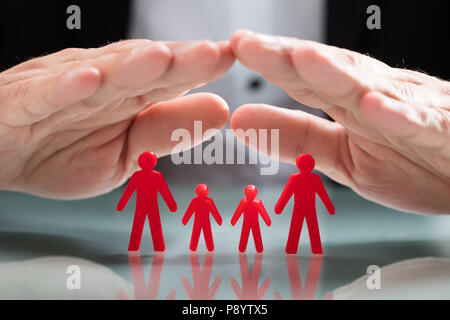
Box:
274;255;322;300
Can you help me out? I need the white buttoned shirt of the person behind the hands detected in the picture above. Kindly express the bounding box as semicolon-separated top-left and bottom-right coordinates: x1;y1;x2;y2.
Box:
129;0;325;179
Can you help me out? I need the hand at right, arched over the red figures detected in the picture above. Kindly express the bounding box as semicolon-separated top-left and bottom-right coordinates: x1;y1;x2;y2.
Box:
231;31;450;214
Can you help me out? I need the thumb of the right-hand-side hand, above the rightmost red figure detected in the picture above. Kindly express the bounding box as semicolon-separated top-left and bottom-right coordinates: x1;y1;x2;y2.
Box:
230;104;351;185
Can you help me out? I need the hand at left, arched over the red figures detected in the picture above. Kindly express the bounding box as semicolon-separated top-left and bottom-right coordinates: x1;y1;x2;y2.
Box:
0;40;234;199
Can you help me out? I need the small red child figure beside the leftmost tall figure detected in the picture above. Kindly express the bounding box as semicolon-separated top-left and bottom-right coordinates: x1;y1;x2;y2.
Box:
181;184;222;251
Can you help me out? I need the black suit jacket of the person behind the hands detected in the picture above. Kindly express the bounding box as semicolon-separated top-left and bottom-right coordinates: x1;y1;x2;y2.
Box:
0;0;450;80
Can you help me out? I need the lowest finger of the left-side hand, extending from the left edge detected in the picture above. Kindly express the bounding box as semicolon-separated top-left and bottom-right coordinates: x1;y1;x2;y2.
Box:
0;67;101;126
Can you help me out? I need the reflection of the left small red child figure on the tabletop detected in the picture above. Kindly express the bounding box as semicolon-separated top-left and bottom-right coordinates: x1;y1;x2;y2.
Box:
181;252;222;300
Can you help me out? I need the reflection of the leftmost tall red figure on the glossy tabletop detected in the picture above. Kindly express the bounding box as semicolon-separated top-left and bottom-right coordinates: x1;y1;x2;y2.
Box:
119;252;176;300
